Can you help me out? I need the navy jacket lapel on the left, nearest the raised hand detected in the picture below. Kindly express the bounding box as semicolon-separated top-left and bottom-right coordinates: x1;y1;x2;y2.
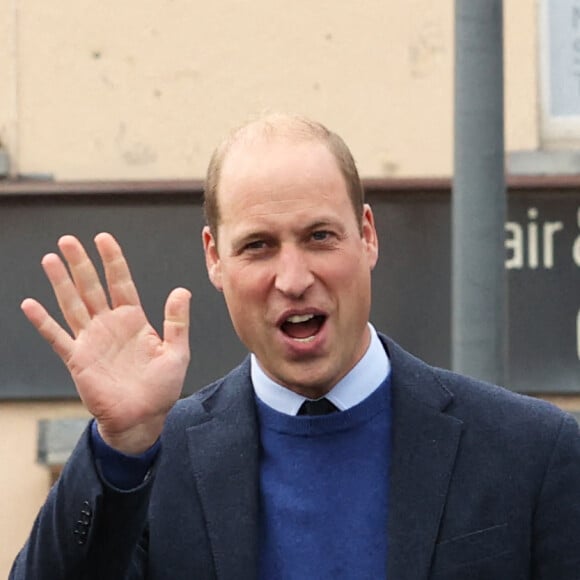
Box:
187;361;259;580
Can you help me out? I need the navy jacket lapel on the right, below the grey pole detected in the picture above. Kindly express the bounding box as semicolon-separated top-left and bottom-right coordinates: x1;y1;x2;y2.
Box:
382;337;462;580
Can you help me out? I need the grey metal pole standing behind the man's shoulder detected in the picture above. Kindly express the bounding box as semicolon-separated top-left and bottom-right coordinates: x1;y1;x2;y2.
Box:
451;0;507;384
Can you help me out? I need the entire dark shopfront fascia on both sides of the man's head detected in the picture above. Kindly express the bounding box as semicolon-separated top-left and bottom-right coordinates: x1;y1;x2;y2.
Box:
0;179;580;399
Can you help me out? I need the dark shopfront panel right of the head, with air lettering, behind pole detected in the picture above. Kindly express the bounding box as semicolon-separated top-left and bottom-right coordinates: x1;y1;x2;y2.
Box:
369;189;580;393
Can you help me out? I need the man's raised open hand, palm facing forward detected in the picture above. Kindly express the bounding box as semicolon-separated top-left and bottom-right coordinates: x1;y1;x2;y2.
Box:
21;233;191;453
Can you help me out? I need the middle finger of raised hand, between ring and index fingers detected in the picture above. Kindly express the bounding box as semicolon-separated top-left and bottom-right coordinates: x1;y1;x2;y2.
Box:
58;236;109;315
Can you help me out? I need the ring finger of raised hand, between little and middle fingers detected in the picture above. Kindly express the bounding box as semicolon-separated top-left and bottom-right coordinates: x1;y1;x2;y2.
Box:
41;254;91;336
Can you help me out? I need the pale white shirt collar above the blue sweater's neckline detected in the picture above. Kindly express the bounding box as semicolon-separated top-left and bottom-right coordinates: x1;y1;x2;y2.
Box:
251;323;391;415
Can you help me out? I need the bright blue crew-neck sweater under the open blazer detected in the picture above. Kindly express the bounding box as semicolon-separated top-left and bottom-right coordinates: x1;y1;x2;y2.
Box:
258;379;391;580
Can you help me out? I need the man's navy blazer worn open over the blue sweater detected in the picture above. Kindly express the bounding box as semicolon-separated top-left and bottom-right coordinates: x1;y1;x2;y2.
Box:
10;335;580;580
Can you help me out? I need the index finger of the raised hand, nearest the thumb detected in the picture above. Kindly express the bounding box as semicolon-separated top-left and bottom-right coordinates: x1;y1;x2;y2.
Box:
95;233;141;308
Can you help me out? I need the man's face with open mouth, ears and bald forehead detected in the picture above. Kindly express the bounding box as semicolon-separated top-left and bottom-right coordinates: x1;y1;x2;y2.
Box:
203;137;378;397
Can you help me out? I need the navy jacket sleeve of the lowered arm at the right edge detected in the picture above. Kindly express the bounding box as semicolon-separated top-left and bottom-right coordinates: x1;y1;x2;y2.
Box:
532;415;580;580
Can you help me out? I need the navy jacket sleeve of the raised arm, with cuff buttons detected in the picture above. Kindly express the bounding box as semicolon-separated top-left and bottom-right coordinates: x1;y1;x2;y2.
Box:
9;429;154;580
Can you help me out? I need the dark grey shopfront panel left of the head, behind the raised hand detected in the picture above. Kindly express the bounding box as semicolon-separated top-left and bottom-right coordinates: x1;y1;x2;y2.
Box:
0;194;244;399
